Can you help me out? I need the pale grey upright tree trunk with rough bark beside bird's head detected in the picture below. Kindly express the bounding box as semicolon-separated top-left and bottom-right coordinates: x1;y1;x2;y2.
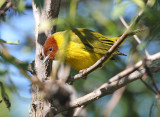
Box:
30;0;61;117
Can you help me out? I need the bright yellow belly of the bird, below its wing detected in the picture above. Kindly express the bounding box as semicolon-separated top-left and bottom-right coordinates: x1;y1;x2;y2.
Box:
65;43;102;70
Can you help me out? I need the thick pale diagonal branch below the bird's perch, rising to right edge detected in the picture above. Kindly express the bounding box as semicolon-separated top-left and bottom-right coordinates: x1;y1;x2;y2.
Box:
54;52;160;113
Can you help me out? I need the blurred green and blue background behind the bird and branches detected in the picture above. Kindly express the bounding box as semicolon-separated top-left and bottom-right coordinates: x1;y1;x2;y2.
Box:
0;0;160;117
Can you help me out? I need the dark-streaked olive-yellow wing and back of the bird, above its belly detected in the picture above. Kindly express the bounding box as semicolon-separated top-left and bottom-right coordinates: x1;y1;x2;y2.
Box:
71;28;124;55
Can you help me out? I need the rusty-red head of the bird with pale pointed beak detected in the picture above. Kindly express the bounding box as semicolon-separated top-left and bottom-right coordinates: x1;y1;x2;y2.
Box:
43;36;58;63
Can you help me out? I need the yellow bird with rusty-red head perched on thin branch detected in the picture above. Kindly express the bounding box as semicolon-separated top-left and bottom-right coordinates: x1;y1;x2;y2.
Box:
43;28;140;70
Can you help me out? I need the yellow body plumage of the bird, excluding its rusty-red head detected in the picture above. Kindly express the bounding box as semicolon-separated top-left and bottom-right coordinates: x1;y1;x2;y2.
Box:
52;28;123;70
